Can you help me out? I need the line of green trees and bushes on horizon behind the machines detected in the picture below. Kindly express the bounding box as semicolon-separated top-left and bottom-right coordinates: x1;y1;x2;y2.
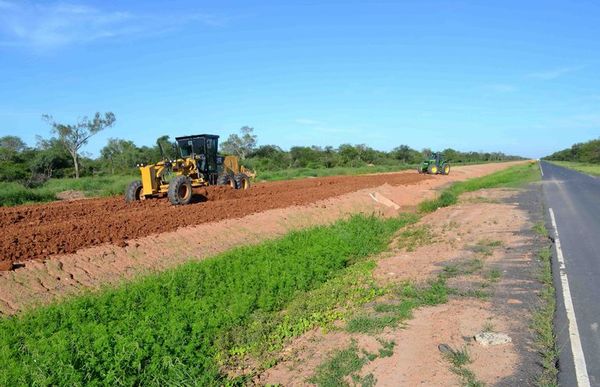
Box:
0;113;519;186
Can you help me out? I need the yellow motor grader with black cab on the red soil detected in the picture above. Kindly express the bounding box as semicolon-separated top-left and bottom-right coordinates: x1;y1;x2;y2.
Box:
125;134;256;205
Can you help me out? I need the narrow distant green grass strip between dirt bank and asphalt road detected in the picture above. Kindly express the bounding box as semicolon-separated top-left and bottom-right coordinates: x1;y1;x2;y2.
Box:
419;162;540;213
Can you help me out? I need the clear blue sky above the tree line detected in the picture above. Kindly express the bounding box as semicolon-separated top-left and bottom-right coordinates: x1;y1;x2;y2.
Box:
0;0;600;157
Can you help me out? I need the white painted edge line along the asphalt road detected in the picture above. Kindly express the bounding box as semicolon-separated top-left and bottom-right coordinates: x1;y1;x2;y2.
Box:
549;208;590;387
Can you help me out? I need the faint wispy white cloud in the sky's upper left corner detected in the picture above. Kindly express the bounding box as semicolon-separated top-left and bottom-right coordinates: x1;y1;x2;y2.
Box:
0;0;227;51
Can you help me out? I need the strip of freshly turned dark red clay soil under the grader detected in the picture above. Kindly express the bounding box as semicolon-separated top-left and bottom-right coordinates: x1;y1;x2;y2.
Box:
0;173;431;270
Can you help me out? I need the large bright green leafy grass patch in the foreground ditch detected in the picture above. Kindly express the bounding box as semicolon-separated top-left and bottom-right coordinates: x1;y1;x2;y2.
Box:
0;215;416;385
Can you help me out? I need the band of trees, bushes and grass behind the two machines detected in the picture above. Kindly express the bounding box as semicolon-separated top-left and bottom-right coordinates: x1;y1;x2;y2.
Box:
0;126;520;206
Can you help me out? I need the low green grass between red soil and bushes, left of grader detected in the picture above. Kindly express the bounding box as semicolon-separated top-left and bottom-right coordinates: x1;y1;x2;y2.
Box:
0;176;139;206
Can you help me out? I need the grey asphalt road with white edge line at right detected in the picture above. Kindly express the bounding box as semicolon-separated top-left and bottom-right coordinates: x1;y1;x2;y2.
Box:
541;162;600;386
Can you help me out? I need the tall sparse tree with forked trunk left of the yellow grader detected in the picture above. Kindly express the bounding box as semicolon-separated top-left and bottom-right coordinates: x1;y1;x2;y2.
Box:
42;112;115;179
